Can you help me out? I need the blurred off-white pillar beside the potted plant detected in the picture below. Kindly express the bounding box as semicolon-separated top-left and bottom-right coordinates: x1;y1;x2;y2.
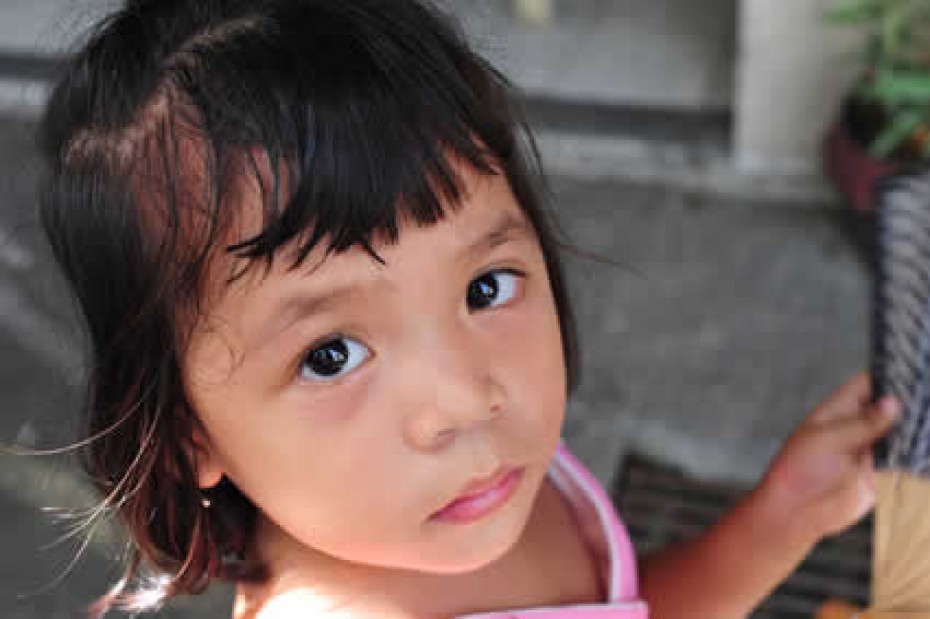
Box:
734;0;862;172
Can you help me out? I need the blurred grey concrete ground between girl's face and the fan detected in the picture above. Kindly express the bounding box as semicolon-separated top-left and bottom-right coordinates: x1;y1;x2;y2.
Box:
556;179;869;482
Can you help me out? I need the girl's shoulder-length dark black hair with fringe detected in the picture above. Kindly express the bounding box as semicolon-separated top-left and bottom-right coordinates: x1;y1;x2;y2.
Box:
40;0;578;614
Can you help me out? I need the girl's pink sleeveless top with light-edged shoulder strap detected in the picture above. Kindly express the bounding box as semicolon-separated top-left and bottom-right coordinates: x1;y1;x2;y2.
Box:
458;444;649;619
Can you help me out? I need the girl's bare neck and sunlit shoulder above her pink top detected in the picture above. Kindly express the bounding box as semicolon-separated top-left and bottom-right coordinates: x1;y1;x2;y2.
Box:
228;481;603;619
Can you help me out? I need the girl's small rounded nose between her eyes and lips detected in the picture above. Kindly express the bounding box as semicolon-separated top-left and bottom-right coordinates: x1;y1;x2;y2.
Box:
402;325;505;451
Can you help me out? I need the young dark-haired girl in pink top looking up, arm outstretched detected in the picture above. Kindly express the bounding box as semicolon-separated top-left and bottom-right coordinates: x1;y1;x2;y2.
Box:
42;0;895;619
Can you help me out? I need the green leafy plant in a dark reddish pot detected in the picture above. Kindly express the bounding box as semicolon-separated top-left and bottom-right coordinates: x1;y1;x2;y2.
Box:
824;0;930;213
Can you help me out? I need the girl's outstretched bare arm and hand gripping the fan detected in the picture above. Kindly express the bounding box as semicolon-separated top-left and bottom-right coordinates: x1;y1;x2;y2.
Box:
641;374;899;619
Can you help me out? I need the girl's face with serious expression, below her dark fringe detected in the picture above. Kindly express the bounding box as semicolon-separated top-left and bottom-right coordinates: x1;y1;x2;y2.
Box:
185;165;566;573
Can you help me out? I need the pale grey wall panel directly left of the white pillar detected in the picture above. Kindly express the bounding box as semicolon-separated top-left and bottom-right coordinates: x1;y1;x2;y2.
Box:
441;0;737;110
